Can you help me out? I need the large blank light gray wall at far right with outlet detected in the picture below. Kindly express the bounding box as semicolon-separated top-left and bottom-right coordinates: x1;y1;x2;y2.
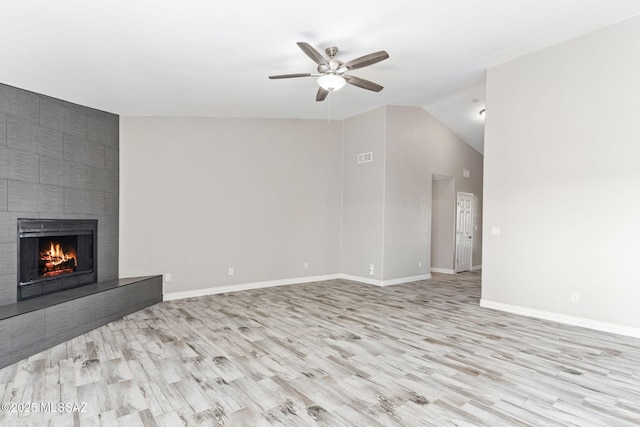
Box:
482;17;640;333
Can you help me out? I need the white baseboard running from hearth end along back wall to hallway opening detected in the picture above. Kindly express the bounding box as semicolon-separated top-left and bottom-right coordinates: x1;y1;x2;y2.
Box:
162;274;431;301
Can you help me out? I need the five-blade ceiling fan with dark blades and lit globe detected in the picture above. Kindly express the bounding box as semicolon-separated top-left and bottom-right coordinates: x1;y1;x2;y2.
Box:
269;42;389;101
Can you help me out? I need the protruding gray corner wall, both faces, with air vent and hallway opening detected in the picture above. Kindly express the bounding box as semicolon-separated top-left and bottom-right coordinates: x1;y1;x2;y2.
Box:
342;106;483;281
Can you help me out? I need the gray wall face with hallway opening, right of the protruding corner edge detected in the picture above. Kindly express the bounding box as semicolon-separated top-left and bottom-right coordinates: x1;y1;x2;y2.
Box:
385;106;483;280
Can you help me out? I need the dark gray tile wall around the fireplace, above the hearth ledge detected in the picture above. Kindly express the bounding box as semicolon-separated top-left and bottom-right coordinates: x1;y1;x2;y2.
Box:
0;83;119;306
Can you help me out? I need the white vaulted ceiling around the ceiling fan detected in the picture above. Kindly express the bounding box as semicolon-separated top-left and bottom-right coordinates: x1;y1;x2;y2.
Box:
0;0;640;152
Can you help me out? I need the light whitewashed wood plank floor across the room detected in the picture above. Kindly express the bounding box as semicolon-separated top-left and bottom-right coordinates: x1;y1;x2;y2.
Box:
0;272;640;427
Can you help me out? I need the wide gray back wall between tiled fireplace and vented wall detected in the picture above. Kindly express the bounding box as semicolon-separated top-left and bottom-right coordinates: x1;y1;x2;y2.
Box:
120;117;342;293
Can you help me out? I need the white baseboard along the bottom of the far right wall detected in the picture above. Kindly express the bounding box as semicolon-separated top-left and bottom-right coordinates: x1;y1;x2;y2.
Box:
480;299;640;338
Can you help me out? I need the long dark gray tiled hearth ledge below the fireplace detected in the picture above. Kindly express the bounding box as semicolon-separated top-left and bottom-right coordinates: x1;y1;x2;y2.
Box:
0;276;162;368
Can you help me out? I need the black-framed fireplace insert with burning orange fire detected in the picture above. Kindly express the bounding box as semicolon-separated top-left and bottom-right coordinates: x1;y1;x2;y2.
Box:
18;219;98;301
